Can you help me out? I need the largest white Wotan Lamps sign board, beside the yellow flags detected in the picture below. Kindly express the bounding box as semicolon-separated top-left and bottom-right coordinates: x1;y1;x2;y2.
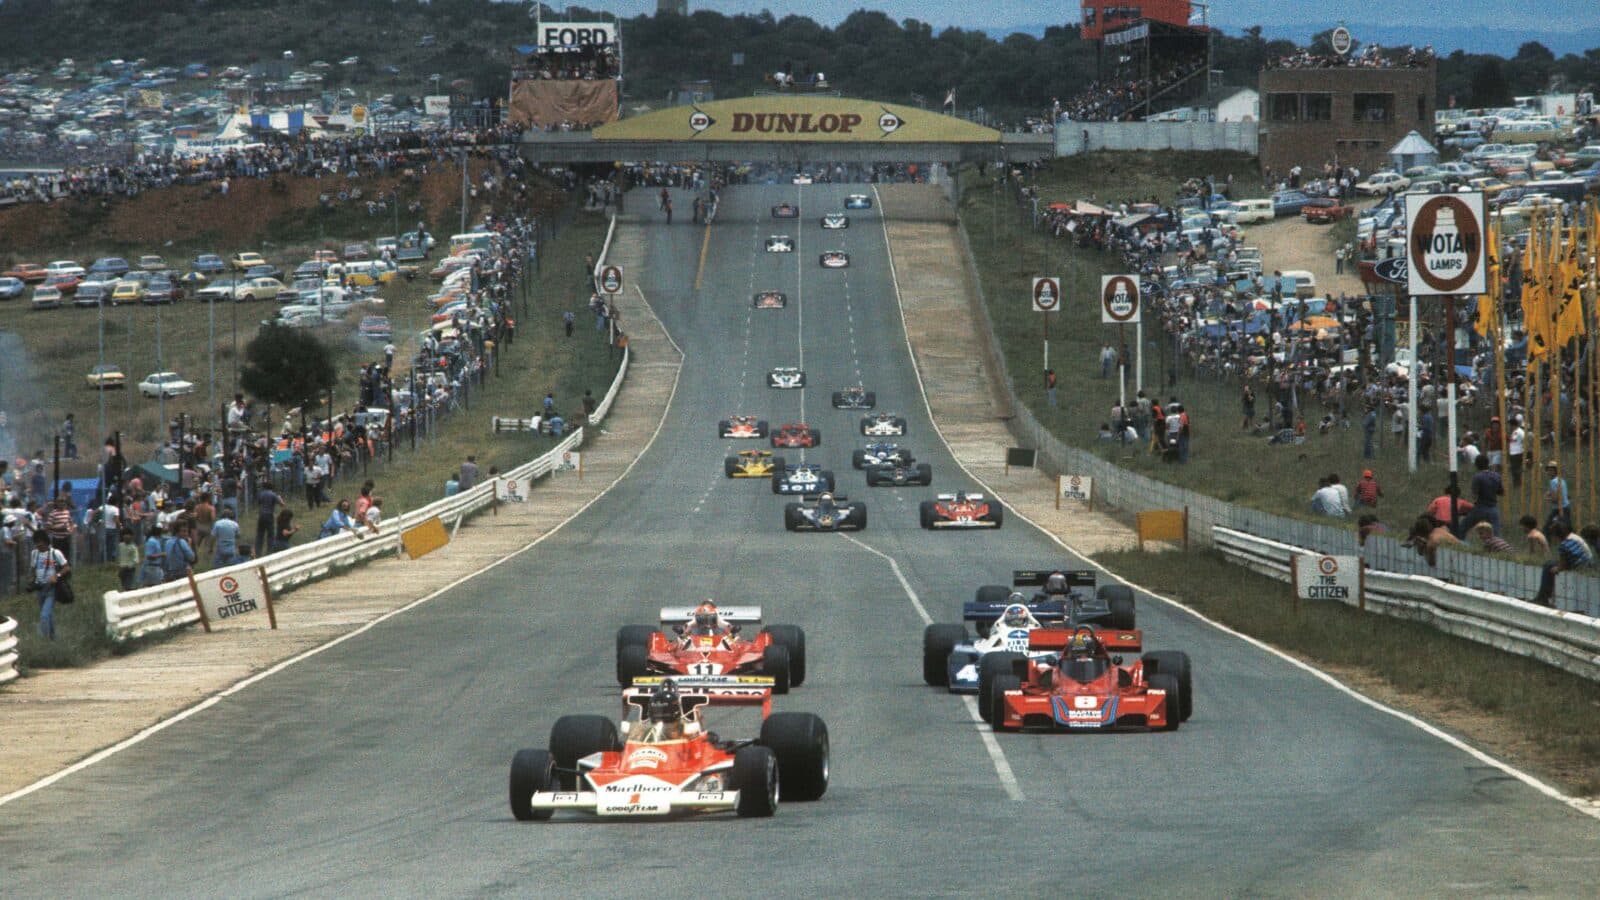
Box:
1405;191;1490;296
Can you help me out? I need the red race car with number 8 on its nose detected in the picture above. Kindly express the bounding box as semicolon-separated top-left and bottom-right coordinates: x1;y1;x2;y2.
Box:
978;625;1194;732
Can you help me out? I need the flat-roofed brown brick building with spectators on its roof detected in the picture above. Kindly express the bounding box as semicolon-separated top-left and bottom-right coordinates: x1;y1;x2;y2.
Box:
1261;59;1437;173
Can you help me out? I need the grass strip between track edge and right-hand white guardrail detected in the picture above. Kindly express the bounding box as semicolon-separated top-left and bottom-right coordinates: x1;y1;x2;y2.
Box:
1094;551;1600;796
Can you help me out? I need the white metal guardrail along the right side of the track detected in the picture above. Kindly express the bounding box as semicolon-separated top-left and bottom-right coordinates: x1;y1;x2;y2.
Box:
1211;527;1600;681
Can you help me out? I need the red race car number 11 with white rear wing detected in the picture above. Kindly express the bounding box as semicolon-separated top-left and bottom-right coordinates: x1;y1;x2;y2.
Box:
616;601;805;693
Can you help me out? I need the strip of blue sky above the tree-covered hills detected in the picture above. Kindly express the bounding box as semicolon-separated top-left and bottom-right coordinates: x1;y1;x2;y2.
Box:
547;0;1600;30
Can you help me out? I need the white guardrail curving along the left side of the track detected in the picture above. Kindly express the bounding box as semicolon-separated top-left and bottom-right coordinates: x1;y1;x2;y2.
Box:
92;218;630;643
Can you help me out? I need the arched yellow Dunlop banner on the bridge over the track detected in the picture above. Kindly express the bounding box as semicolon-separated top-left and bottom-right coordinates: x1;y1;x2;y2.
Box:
595;96;1000;144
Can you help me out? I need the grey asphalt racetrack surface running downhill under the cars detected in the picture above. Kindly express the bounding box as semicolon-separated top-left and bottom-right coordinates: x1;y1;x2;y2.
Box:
0;184;1600;897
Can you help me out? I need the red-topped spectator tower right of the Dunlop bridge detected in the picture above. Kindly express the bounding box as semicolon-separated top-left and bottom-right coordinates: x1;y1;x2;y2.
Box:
1078;0;1213;120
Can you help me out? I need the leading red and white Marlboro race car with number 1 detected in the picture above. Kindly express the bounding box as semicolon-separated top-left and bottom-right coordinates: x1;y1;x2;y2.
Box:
510;676;829;822
